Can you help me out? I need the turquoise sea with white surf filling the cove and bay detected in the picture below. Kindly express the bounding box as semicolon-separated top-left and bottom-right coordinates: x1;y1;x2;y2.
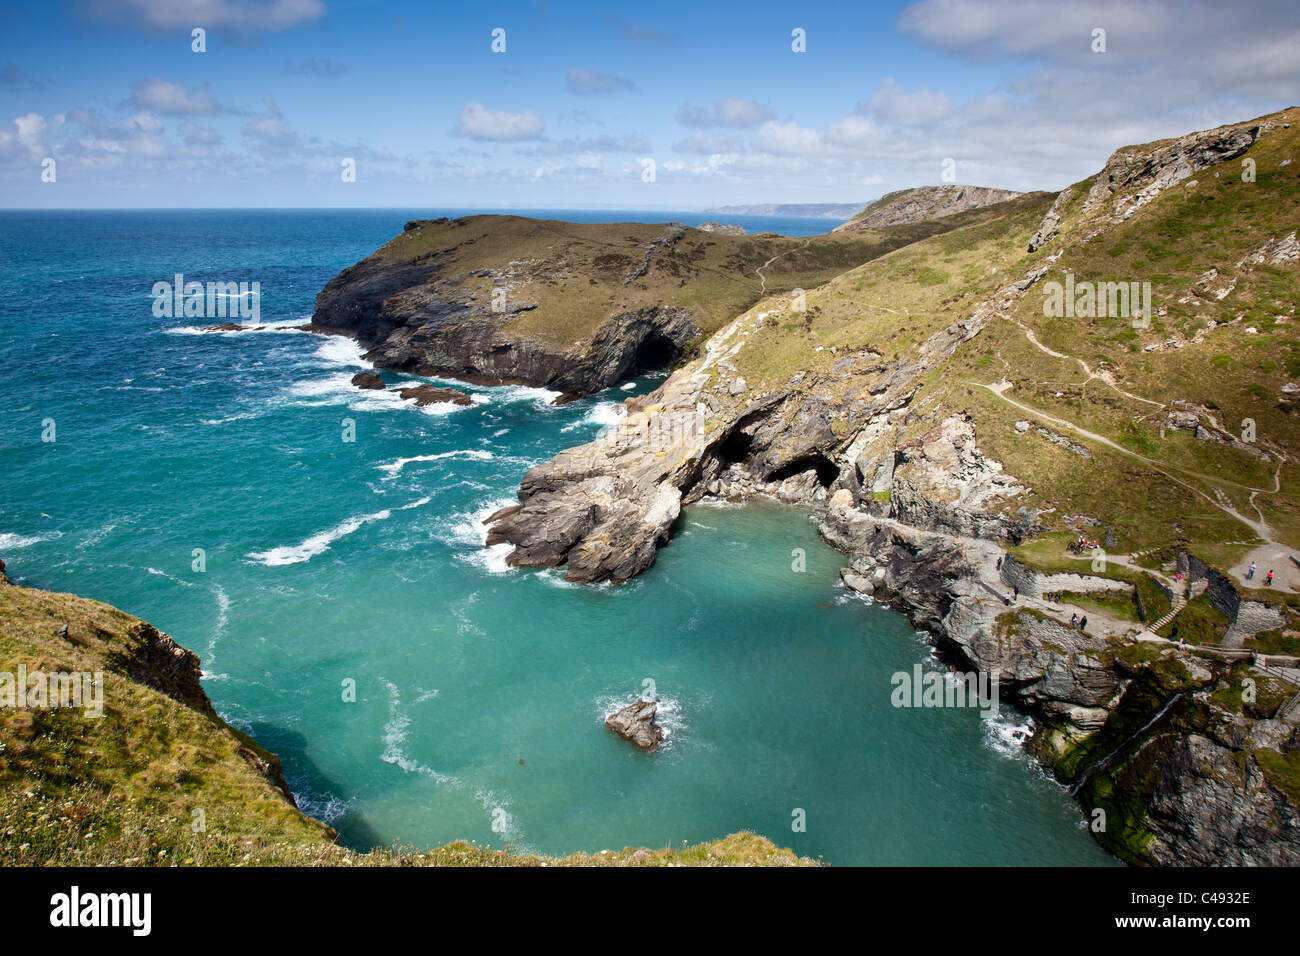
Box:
0;211;1110;865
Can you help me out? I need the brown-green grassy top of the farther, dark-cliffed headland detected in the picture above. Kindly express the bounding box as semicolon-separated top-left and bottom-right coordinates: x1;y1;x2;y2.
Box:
359;209;1045;345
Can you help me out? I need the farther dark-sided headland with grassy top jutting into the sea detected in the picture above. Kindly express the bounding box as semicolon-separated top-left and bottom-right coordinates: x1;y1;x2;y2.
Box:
308;216;1019;398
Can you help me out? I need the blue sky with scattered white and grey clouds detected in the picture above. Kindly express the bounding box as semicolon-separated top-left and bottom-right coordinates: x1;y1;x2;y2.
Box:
0;0;1300;209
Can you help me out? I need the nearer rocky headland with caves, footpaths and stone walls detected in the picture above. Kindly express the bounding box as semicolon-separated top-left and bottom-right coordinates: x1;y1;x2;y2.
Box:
478;111;1300;865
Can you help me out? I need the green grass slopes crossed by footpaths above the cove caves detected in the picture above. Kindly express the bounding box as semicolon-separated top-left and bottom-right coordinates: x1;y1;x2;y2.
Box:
735;109;1300;566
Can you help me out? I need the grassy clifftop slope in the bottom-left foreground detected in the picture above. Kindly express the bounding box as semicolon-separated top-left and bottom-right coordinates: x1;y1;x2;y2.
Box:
0;574;813;866
